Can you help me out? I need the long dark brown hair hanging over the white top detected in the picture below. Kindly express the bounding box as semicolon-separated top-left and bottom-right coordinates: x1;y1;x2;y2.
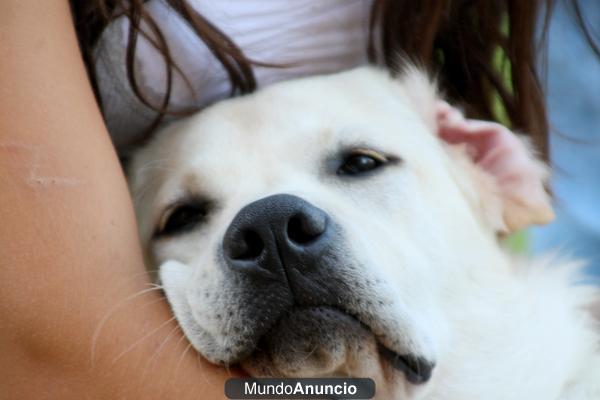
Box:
71;0;592;157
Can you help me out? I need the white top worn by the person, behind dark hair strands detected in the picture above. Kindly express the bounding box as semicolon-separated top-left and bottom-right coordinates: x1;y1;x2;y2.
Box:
95;0;372;148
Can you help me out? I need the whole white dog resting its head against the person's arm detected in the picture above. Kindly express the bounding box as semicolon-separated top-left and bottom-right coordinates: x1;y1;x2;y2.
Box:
130;67;600;400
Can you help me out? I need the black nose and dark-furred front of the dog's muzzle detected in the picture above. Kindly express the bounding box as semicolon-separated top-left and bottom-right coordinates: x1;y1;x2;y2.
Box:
222;194;433;384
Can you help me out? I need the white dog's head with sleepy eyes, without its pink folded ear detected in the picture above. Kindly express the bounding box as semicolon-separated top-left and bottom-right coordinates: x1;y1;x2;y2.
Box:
130;68;549;393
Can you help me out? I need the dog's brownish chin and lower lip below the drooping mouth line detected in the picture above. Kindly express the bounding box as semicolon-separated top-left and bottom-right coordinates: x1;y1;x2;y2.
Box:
241;307;429;387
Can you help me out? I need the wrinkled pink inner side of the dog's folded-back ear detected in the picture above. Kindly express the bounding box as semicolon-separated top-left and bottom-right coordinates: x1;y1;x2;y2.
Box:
436;101;554;234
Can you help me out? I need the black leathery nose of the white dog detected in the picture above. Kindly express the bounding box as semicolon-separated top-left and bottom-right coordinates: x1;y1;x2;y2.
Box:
223;194;331;275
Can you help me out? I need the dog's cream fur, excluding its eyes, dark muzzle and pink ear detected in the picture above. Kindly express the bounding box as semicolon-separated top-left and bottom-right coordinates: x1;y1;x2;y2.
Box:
129;68;600;400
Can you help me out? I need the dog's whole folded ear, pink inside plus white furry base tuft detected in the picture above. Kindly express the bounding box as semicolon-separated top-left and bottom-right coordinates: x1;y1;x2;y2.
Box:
397;65;554;234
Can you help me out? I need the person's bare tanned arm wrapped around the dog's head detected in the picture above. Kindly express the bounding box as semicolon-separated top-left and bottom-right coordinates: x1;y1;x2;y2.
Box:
0;0;234;400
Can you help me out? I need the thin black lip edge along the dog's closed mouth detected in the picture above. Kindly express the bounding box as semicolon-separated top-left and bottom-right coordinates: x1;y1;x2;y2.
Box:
255;305;435;385
